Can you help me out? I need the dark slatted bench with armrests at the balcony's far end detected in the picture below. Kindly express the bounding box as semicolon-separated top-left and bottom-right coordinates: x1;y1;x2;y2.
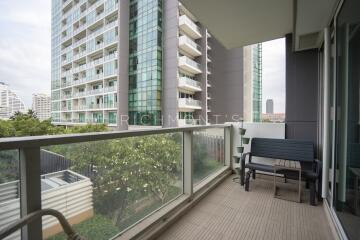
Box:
240;138;321;205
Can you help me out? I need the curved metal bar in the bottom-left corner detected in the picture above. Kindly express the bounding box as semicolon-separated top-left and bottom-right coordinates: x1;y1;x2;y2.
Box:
0;209;86;240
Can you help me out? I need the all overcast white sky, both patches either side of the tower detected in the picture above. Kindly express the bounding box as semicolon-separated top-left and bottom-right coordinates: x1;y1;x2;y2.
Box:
0;0;285;112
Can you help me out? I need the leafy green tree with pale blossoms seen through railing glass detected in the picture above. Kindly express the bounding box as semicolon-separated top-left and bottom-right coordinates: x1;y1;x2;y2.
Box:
50;134;182;225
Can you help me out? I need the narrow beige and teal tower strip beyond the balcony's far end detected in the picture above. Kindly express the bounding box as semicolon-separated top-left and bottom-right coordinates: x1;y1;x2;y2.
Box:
244;43;262;122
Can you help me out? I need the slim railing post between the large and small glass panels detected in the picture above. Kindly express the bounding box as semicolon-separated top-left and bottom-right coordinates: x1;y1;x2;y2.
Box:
183;131;193;198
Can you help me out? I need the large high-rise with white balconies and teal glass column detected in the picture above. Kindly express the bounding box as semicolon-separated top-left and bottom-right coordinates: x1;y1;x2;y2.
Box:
51;0;242;129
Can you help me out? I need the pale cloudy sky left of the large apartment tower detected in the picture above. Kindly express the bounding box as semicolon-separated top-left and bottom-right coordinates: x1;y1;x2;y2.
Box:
0;0;51;107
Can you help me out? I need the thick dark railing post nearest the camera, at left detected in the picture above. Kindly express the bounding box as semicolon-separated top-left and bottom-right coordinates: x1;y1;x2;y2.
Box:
20;147;42;240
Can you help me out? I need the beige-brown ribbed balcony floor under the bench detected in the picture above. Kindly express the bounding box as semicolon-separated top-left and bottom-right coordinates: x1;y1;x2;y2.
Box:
159;175;333;240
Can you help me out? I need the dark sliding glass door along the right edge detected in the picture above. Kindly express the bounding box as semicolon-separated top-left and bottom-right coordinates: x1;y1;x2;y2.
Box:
334;0;360;239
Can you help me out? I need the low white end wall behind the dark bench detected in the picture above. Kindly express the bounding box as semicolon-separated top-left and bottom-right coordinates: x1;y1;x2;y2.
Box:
231;122;285;168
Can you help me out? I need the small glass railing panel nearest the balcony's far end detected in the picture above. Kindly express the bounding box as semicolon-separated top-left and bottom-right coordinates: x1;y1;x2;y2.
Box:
192;128;225;185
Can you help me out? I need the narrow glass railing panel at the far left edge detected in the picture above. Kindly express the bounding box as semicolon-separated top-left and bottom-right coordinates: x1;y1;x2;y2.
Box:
0;150;21;239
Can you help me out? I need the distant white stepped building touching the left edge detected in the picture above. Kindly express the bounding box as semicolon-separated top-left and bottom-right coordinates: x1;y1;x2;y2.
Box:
0;82;25;119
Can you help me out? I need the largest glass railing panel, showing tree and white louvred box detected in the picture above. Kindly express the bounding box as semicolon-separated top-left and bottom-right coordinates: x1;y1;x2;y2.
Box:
42;133;183;240
